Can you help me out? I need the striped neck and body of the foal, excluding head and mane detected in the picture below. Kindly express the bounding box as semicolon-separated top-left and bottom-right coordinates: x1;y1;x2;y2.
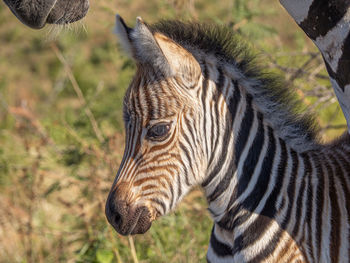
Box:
202;66;350;262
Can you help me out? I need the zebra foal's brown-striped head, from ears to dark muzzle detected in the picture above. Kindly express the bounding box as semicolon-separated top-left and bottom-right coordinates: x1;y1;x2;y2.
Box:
106;16;205;235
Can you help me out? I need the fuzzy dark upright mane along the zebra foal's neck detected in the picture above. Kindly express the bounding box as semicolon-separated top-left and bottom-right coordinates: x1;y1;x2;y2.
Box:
149;20;318;151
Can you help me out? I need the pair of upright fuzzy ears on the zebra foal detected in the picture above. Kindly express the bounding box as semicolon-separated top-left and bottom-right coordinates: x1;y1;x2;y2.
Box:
116;15;201;82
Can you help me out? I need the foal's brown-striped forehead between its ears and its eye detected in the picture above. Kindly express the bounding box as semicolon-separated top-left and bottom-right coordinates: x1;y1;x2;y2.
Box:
124;69;185;121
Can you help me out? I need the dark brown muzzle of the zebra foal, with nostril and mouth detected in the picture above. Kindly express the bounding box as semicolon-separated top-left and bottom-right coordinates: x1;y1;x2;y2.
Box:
106;198;152;236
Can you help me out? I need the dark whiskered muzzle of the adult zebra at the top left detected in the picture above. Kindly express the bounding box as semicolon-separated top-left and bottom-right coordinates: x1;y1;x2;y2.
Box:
4;0;89;29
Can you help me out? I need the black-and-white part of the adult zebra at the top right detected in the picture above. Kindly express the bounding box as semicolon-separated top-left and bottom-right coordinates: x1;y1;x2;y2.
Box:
280;0;350;133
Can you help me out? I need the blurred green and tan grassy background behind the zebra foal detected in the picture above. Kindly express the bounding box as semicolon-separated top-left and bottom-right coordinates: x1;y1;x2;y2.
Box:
0;0;345;263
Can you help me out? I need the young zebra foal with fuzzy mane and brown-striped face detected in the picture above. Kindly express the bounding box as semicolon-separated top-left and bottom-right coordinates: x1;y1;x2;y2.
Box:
106;16;350;262
